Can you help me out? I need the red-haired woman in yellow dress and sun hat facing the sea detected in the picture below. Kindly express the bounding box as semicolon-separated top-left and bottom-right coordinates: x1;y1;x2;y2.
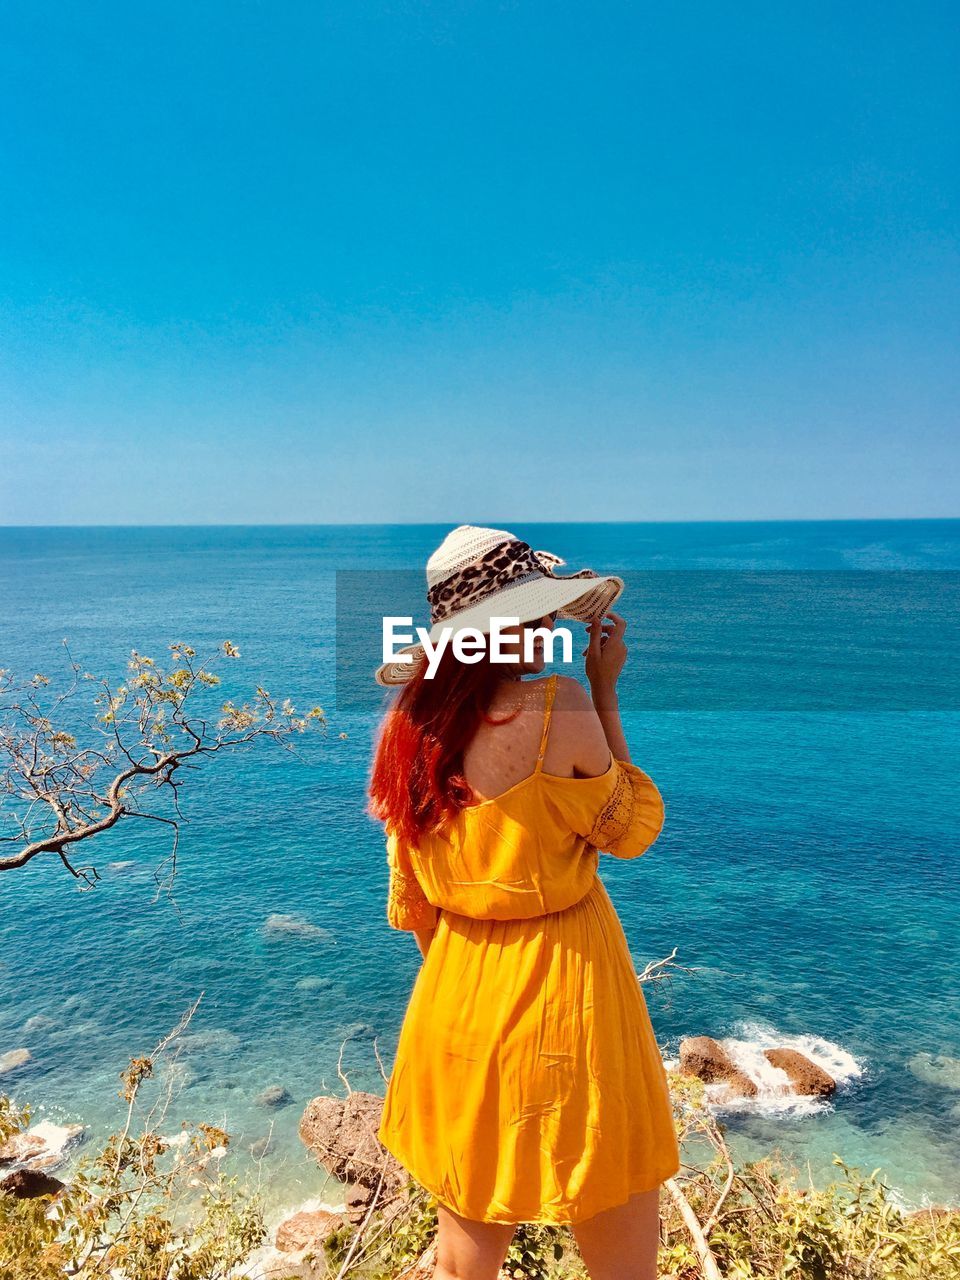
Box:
370;526;680;1280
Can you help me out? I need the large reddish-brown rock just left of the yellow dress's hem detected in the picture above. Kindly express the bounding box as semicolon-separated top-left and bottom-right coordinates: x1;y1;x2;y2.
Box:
300;1091;410;1208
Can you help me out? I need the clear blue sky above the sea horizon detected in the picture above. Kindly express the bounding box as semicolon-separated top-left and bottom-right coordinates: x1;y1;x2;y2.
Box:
0;0;960;525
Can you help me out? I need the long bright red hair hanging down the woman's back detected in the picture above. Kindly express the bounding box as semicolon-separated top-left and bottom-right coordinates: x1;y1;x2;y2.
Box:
369;646;517;845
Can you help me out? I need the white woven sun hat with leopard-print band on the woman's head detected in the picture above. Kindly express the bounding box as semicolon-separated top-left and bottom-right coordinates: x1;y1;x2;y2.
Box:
376;525;623;685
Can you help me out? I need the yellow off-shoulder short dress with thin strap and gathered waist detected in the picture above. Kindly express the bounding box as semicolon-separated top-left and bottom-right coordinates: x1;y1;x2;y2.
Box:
378;676;680;1224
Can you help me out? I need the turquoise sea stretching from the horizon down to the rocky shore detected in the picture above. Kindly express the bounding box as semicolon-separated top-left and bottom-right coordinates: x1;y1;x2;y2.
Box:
0;521;960;1206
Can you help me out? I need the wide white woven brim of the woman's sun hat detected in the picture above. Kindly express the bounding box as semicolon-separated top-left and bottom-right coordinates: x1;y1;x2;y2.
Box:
375;573;623;686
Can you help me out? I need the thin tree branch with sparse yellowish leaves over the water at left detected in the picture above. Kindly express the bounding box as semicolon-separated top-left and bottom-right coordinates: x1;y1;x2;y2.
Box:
0;640;325;896
